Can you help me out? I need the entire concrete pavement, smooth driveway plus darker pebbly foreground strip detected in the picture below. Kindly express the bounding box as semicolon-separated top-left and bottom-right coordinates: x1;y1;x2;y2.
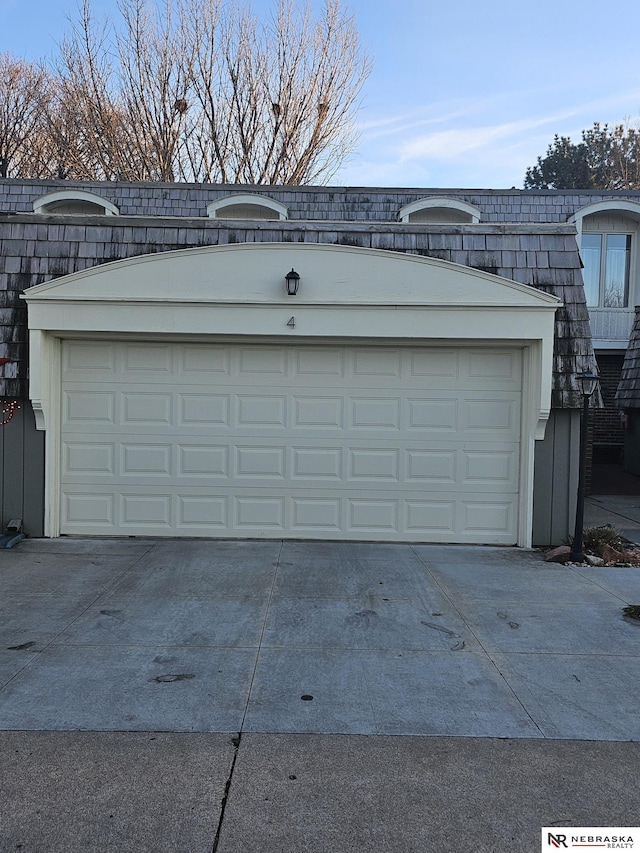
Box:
0;539;640;853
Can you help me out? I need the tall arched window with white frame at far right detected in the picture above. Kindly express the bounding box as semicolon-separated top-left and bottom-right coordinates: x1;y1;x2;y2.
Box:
569;199;640;310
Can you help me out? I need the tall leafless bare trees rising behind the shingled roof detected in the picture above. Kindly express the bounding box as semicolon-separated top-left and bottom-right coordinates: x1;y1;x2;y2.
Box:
0;0;370;184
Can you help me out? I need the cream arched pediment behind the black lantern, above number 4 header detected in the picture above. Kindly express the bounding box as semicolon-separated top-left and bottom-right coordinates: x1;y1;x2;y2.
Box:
26;243;558;310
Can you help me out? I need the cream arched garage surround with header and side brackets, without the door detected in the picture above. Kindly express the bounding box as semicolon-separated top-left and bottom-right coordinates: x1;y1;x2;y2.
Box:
24;243;560;430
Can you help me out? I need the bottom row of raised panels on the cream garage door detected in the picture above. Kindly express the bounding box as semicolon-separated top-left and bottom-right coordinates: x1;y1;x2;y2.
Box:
58;486;517;544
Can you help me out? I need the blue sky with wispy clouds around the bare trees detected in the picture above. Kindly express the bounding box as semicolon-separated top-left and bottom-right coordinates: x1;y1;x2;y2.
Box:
0;0;640;189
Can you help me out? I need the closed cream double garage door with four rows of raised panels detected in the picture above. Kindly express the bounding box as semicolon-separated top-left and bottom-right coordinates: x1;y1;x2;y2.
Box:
61;341;521;544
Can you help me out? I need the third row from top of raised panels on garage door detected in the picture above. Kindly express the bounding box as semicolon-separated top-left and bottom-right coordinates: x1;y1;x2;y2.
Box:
62;434;518;490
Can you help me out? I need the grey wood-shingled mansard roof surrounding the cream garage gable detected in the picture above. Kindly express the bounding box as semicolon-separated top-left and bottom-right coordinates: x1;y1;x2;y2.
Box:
0;180;620;408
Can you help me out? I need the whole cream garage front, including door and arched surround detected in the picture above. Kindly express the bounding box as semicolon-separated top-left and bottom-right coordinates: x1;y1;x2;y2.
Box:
26;244;558;544
